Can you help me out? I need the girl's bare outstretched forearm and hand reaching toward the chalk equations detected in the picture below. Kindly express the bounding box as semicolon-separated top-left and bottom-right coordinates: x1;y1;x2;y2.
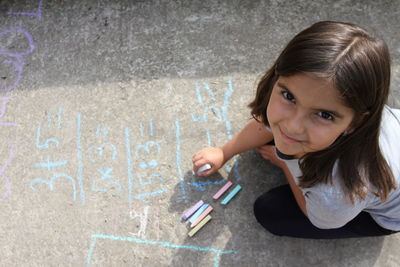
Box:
193;119;273;176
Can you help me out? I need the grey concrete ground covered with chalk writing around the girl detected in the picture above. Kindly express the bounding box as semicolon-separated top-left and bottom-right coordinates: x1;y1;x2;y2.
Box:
0;0;400;266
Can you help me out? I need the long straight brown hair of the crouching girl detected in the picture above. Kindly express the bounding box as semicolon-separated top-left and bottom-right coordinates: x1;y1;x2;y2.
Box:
249;21;396;202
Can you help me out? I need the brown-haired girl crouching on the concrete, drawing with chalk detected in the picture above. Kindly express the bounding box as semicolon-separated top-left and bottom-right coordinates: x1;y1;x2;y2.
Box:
193;21;400;238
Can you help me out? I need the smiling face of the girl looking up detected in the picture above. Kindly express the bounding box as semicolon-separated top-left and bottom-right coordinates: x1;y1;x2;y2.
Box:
267;73;354;158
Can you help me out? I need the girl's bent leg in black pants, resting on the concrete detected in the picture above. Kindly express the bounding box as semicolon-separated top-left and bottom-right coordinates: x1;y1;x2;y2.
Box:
254;185;394;239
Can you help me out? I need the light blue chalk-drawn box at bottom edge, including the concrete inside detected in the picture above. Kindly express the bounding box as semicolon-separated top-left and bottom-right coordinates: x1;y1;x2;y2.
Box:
86;234;236;267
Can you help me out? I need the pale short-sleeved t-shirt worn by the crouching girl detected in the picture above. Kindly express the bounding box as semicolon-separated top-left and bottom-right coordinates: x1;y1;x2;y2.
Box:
277;106;400;231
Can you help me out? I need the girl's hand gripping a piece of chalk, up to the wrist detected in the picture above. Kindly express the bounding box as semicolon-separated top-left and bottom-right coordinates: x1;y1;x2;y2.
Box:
192;147;225;176
